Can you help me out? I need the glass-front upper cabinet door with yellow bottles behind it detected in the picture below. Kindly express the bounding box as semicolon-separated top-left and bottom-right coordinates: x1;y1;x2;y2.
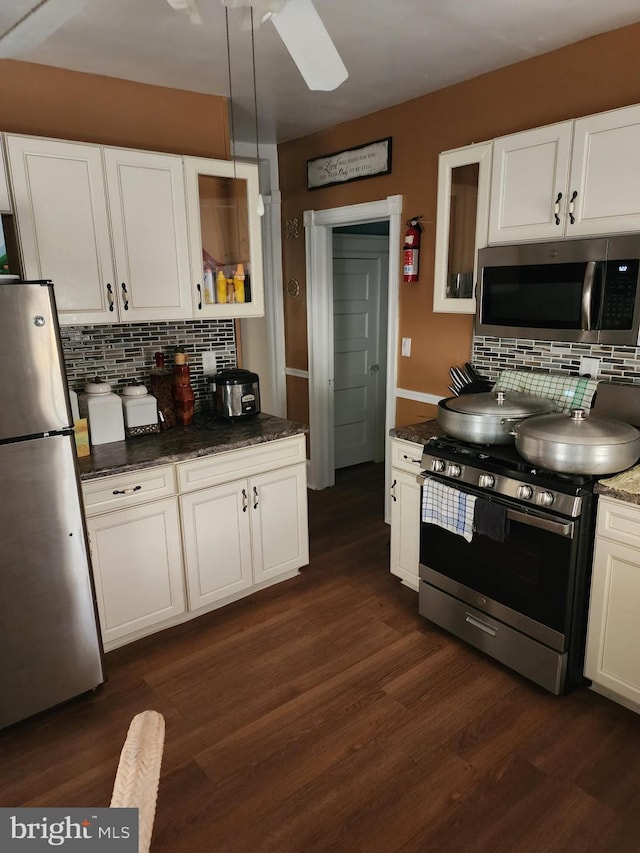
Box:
184;157;264;319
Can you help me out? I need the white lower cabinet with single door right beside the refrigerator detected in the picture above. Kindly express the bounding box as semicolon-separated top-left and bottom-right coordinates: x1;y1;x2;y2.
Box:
85;475;185;651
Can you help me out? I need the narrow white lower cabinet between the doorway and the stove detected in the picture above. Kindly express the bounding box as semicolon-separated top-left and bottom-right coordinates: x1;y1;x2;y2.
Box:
389;439;422;591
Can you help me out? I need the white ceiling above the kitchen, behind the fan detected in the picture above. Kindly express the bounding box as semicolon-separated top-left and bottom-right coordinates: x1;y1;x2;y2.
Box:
0;0;640;142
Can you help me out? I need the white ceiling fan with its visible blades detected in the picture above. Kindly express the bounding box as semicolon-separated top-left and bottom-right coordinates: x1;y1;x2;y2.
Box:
0;0;349;91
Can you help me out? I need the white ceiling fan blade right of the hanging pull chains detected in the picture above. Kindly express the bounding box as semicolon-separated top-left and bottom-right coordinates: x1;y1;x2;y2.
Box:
271;0;349;92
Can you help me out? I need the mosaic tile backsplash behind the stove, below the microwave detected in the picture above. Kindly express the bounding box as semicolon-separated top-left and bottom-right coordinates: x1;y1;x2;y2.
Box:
472;335;640;384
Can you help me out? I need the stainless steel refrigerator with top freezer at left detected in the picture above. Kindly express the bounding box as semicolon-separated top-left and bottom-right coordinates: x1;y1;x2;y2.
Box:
0;279;104;728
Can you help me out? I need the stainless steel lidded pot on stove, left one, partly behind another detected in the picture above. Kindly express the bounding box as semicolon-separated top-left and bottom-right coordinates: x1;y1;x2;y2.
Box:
438;391;556;444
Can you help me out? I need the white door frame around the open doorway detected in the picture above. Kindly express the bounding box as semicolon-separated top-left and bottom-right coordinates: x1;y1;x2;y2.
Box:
304;195;402;510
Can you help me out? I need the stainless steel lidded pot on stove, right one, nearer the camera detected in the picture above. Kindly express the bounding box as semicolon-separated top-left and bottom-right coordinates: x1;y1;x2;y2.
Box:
515;409;640;474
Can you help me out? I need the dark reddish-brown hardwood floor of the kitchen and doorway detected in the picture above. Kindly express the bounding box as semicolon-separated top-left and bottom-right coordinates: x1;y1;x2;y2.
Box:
0;465;640;853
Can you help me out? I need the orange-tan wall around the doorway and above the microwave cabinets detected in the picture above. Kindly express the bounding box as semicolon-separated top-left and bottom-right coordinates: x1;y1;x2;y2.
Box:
278;24;640;423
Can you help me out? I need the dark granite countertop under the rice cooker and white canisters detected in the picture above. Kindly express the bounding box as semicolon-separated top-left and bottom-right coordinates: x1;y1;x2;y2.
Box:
78;414;308;480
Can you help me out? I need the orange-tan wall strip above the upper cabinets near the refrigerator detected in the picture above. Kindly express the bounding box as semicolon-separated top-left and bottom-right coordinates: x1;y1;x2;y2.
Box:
0;59;229;159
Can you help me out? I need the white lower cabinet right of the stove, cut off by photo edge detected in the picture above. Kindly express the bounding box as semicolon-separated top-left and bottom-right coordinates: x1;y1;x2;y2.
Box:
585;498;640;711
